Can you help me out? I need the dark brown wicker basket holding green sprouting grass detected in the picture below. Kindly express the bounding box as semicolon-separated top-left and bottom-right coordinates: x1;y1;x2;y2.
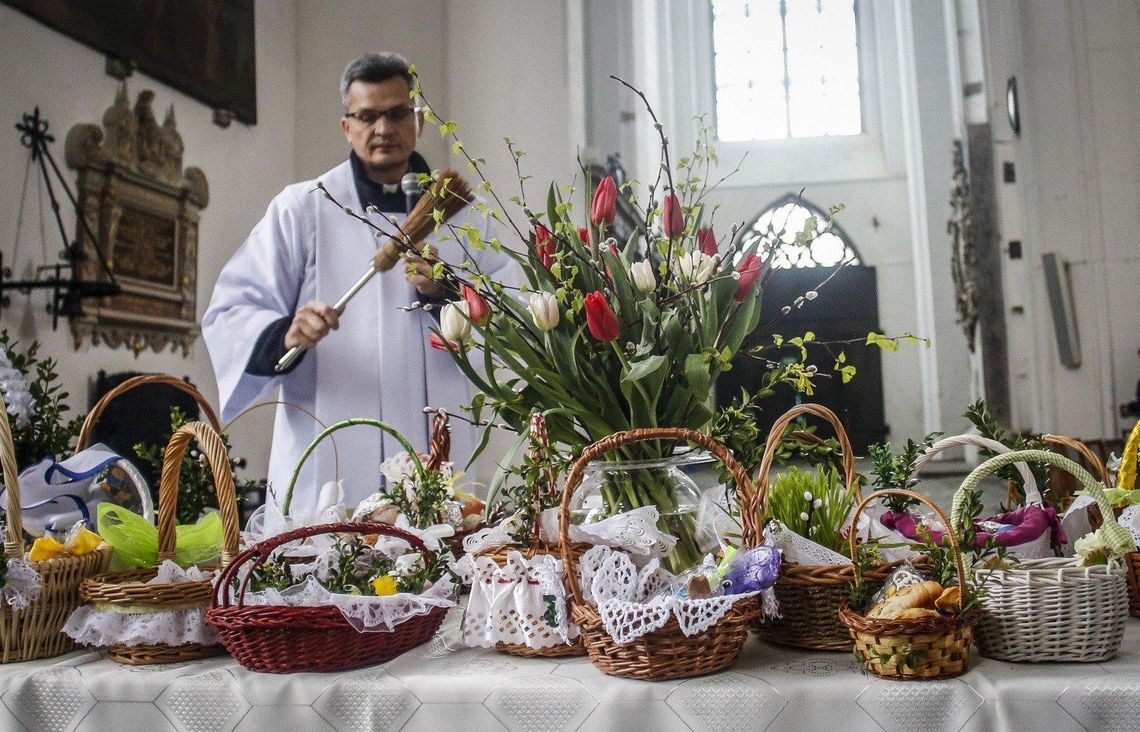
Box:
754;404;897;651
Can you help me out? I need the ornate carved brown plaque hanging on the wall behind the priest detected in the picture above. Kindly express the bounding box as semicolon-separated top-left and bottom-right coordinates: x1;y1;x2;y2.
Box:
65;82;210;356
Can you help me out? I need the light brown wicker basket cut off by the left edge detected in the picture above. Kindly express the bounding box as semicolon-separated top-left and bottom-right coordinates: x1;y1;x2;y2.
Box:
0;402;111;664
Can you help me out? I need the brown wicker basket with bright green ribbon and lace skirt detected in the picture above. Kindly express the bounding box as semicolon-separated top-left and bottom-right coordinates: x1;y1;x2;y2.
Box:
80;422;238;666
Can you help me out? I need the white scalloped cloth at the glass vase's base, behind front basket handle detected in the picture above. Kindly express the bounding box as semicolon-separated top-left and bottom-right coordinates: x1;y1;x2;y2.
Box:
463;506;677;556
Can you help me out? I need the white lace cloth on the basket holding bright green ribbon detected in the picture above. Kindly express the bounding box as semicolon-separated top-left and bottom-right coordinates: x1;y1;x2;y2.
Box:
63;560;218;646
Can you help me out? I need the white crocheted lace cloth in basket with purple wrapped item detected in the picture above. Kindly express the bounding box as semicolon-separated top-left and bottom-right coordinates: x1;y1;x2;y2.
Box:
578;546;776;643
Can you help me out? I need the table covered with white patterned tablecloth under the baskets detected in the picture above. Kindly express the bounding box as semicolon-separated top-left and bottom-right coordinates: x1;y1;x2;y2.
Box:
0;610;1140;732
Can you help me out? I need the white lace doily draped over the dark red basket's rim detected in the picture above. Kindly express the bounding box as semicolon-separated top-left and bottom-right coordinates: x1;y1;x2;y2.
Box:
235;576;455;633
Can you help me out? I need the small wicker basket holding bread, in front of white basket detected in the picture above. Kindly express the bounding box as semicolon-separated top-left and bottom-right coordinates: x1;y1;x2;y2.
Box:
839;488;978;680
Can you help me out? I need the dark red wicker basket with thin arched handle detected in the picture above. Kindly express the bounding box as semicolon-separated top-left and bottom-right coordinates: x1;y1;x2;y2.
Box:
206;523;447;674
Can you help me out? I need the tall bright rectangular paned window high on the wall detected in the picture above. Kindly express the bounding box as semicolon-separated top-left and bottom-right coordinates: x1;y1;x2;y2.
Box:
711;0;863;141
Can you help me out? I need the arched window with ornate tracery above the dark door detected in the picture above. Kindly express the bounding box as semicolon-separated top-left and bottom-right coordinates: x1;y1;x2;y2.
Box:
741;193;863;269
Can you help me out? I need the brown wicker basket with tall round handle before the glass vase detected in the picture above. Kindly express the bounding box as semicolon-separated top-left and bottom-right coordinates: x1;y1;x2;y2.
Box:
559;428;760;681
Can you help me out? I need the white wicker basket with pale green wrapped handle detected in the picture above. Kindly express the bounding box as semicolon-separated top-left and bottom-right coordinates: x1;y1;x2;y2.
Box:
951;450;1131;661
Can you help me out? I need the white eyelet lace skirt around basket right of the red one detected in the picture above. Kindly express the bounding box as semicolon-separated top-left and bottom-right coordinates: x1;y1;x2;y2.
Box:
455;552;578;648
